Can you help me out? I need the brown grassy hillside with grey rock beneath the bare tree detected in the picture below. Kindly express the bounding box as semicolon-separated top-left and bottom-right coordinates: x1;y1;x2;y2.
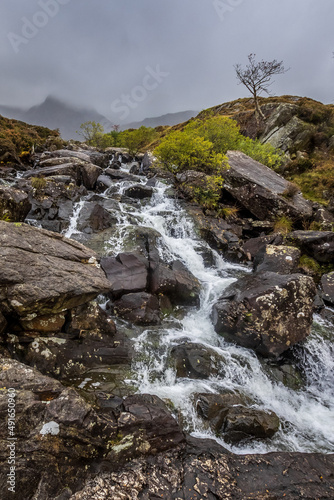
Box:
155;95;334;206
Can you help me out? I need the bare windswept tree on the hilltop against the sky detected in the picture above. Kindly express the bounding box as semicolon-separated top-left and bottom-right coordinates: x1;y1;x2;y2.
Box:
234;54;288;120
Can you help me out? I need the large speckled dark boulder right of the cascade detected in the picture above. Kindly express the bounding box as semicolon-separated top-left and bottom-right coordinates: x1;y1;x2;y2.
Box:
212;272;316;357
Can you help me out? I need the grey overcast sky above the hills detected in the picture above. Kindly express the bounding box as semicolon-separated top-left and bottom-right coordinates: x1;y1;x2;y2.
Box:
0;0;334;123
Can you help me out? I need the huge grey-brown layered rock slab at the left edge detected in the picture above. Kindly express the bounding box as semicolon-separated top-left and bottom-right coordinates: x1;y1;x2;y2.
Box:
0;221;110;321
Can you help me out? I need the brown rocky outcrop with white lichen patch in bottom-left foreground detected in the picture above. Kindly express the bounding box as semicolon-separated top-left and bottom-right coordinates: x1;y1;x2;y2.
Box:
0;357;184;500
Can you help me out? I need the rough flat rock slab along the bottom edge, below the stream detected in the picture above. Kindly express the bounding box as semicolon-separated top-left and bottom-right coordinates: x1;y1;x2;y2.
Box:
70;437;334;500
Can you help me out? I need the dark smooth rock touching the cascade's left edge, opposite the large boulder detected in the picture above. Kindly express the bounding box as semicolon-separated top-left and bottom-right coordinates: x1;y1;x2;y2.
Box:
150;261;200;305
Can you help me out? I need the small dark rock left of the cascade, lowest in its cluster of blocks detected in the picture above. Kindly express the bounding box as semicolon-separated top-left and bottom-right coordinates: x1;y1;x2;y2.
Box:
112;292;160;325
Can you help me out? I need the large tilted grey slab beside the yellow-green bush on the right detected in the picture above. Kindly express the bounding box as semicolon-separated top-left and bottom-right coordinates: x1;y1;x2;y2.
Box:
224;151;313;220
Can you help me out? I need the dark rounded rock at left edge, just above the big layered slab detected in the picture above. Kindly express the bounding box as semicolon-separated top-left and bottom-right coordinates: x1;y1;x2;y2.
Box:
0;186;31;222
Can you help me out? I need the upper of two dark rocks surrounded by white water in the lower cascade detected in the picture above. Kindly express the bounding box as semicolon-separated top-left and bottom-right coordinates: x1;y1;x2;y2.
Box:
171;342;224;379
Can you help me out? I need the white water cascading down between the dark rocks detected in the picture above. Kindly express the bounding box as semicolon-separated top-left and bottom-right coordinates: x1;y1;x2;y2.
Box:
66;167;334;453
